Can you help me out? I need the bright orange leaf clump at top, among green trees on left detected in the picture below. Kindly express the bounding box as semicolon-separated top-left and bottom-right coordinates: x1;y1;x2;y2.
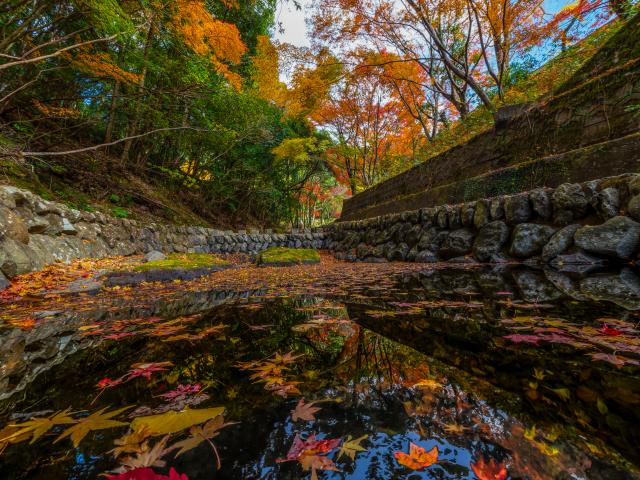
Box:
171;0;247;89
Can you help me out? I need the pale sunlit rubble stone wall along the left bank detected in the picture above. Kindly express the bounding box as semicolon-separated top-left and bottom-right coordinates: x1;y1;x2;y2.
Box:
0;186;324;287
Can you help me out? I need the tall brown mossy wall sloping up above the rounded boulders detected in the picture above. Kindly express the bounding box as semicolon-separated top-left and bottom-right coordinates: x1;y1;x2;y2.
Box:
341;15;640;221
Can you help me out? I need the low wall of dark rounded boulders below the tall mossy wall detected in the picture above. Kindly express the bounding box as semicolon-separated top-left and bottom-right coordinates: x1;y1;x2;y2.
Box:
327;174;640;265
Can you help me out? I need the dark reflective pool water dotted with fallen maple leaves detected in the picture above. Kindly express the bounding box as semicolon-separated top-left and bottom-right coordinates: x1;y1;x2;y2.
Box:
0;268;640;480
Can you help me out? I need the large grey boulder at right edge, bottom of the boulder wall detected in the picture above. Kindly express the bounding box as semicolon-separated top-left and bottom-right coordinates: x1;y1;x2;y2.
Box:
574;216;640;260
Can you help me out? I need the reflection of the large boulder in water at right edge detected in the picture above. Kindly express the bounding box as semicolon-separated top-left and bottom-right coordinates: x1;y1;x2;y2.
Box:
580;268;640;310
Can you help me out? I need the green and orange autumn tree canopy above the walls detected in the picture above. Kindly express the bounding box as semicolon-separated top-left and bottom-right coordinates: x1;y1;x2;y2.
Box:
0;0;637;226
